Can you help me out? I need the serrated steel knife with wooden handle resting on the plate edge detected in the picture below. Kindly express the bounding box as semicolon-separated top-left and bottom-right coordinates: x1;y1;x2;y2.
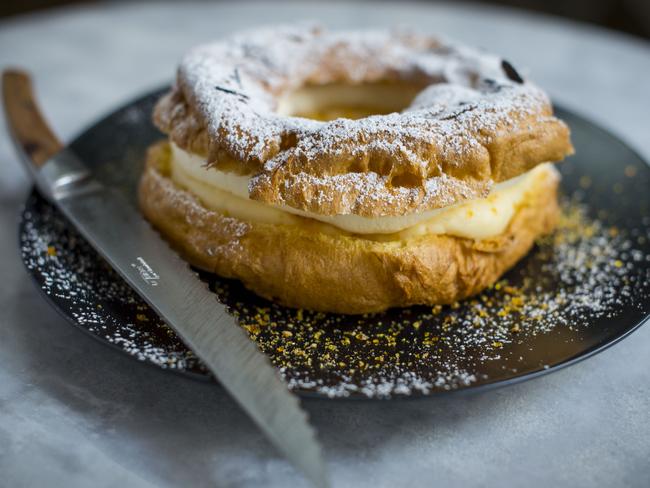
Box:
2;70;329;487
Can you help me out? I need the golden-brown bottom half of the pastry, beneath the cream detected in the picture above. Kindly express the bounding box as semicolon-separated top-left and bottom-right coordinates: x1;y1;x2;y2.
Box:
139;142;559;314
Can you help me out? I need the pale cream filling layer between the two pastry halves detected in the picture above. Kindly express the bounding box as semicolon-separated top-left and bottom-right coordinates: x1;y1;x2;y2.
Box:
171;143;558;240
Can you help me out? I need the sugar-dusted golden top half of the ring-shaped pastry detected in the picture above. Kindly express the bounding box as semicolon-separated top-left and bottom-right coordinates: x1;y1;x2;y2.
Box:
154;26;572;217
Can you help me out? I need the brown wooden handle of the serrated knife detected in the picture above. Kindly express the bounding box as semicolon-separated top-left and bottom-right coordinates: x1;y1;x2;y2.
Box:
2;69;63;168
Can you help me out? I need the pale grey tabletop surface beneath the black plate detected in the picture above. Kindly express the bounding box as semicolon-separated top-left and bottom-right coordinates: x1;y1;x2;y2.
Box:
0;2;650;488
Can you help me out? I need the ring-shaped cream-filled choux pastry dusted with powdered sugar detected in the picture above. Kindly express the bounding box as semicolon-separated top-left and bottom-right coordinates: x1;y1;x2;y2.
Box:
139;26;573;313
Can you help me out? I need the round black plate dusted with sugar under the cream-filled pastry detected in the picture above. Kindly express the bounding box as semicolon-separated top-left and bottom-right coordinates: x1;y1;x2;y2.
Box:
20;90;650;398
